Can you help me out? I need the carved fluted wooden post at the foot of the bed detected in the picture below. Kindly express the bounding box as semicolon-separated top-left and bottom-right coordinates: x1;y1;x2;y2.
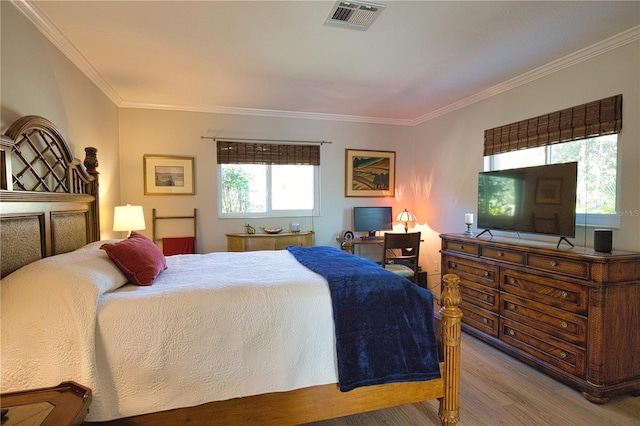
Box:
438;274;462;426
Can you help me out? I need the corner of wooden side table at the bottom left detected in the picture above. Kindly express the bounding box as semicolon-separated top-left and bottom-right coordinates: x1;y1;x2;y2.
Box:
0;382;91;426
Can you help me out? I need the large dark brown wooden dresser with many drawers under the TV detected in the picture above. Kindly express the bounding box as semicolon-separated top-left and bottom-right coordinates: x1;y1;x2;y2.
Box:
440;234;640;403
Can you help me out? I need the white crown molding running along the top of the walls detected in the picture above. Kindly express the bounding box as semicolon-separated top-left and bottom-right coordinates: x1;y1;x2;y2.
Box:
11;0;640;126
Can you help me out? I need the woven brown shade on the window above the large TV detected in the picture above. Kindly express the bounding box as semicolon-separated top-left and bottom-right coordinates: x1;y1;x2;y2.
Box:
484;95;622;156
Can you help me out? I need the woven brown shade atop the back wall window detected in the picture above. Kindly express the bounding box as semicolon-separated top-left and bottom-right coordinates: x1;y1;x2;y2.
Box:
216;140;320;166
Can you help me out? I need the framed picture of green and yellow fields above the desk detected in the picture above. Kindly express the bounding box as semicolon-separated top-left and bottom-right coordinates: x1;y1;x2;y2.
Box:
344;149;396;197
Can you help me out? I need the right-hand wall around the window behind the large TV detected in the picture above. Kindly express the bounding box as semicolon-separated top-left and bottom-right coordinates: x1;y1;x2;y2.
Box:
414;42;640;286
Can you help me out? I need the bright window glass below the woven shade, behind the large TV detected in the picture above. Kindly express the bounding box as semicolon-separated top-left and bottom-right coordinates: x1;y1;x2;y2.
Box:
485;134;620;227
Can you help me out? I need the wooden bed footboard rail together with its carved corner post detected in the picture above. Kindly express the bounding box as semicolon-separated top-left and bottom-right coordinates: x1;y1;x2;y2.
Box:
91;274;462;426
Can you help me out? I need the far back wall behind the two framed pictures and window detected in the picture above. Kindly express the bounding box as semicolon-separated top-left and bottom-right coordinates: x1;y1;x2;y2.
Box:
120;108;413;256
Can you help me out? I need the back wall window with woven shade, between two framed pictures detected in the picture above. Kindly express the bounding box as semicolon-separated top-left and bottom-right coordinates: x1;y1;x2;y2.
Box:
218;141;320;217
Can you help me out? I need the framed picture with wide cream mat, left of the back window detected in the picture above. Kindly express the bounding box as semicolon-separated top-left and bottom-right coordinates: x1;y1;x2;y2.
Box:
144;155;195;195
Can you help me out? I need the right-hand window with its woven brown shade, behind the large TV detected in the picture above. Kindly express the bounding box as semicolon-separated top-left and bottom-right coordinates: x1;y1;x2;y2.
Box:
484;95;622;227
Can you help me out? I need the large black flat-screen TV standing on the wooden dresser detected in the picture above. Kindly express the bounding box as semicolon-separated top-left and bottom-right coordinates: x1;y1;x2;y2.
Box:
477;162;578;237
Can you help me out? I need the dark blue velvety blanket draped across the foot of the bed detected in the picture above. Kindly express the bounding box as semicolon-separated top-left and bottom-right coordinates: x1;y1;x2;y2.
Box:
287;246;440;392
